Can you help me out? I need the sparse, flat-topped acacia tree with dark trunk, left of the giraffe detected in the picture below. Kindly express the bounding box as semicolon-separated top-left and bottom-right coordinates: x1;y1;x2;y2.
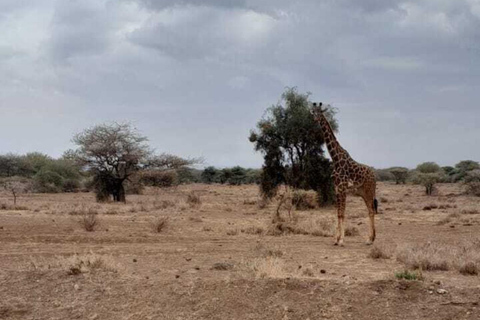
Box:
65;123;192;202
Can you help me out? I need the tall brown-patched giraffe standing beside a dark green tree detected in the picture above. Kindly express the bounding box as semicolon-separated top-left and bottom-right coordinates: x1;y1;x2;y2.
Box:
313;102;378;246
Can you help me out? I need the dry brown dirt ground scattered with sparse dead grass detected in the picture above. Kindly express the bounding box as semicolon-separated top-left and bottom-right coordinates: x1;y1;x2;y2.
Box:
0;184;480;320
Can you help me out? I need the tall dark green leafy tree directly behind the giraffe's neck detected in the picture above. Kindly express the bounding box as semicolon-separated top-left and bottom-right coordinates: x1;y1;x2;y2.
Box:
250;88;338;204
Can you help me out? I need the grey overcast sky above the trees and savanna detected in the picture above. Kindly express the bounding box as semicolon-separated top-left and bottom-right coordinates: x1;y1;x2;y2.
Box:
0;0;480;168
